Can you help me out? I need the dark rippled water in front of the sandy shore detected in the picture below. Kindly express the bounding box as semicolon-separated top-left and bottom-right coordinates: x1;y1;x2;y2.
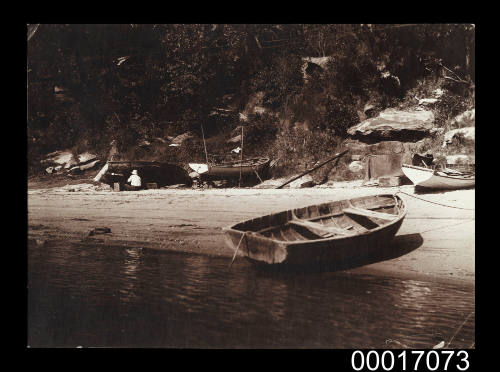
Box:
28;244;475;348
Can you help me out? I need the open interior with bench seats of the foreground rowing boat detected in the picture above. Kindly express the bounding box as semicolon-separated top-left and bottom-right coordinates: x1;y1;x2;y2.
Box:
233;195;404;241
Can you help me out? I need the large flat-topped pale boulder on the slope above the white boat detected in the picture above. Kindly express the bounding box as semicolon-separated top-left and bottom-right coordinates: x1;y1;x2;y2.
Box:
348;108;434;141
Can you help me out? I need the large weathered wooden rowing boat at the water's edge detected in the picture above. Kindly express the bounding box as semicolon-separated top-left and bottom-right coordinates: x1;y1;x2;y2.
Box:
224;194;406;265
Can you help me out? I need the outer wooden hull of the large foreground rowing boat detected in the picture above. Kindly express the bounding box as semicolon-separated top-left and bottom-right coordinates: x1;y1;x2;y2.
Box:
224;195;406;267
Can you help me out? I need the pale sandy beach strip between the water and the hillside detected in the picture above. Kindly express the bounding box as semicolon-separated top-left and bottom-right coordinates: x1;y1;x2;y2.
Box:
28;181;475;285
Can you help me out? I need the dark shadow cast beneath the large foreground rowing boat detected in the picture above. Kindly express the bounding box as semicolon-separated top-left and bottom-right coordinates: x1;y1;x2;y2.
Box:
254;233;424;275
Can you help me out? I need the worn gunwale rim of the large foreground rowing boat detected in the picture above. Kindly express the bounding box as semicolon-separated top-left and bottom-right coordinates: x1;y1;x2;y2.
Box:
222;194;408;247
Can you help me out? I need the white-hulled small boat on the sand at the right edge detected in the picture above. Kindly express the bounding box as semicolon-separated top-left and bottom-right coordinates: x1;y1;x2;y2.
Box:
401;164;476;190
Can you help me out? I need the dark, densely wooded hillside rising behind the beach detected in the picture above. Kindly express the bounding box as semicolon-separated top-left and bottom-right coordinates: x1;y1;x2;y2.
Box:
27;24;475;178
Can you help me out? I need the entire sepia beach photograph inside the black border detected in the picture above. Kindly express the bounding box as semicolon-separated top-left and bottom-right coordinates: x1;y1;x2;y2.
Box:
26;23;476;352
